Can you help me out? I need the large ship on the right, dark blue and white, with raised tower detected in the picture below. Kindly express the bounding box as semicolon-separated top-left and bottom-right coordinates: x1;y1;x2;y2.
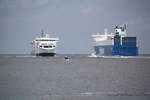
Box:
92;25;138;56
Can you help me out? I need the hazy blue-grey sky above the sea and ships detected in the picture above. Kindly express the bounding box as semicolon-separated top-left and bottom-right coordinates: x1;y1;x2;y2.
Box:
0;0;150;54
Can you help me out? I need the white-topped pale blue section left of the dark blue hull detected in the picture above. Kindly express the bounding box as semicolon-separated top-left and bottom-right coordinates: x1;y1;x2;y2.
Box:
92;29;114;56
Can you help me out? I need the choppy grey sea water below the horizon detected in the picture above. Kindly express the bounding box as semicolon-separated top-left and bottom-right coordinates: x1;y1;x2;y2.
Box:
0;55;150;100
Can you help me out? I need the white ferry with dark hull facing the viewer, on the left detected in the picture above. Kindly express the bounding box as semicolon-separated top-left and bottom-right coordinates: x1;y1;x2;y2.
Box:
31;31;59;56
